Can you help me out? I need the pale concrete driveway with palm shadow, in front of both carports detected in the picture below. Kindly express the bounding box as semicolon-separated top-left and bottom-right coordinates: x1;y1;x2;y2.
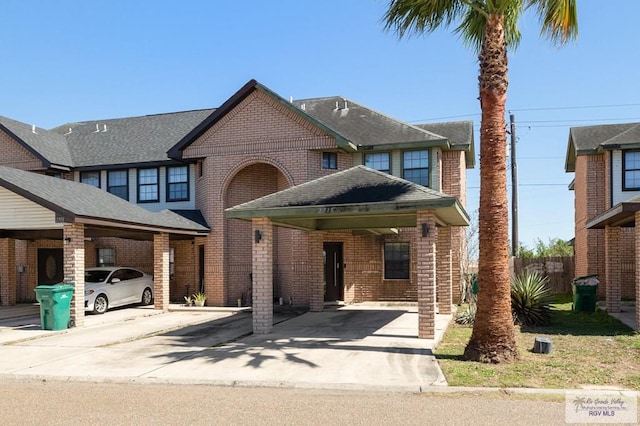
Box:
0;305;450;391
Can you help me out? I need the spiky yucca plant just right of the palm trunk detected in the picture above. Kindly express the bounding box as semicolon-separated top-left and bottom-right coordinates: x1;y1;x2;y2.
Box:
511;271;553;325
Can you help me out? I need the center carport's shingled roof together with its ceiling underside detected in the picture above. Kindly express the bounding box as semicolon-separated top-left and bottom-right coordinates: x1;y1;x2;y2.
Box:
225;166;469;233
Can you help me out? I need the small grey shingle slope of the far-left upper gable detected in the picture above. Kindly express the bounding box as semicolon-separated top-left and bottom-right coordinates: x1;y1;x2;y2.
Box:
0;116;73;167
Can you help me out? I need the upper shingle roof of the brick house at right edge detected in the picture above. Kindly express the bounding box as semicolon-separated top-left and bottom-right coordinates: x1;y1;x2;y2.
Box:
565;123;640;172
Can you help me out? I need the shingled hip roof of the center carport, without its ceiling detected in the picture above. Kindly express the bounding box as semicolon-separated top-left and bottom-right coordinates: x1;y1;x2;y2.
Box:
225;166;469;226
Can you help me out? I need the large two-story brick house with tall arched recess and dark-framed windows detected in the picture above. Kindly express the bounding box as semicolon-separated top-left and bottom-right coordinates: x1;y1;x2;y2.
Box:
0;80;474;338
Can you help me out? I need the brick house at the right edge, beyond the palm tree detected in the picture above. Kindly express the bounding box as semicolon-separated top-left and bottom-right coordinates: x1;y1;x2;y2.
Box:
565;123;640;324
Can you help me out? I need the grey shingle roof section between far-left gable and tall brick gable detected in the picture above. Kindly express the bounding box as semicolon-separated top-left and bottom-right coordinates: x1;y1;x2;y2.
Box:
54;109;214;167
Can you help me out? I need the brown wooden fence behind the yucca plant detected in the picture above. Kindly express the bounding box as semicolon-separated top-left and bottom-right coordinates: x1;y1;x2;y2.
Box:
511;256;575;293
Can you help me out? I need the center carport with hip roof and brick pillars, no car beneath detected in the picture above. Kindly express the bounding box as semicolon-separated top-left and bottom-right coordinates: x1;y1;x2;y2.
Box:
225;166;469;339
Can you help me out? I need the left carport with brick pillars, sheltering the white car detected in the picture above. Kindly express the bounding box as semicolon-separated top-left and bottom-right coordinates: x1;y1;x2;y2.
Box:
0;167;209;326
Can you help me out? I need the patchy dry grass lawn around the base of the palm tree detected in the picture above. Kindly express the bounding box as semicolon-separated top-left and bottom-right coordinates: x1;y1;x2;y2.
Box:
436;296;640;390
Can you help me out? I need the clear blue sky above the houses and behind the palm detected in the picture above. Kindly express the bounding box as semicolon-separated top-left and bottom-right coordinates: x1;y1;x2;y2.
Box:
0;0;640;246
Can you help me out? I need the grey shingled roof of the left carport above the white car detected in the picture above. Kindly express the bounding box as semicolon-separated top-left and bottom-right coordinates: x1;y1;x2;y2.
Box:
0;166;209;240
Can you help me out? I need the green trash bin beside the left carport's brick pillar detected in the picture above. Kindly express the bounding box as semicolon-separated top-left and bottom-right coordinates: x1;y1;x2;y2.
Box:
36;284;73;330
